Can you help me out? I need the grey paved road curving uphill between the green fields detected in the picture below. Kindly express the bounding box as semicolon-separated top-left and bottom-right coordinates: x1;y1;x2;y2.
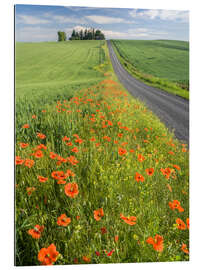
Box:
107;40;189;144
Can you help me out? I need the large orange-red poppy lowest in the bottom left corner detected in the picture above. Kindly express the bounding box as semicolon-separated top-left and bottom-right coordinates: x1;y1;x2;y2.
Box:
38;244;59;265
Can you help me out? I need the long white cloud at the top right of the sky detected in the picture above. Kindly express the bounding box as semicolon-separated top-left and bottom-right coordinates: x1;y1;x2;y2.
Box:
129;9;189;22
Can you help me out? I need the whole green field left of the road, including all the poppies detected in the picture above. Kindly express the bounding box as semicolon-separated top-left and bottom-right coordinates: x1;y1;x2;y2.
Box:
15;41;189;266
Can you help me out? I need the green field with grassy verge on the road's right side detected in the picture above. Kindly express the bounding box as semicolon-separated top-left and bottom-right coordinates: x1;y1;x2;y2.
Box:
112;40;189;99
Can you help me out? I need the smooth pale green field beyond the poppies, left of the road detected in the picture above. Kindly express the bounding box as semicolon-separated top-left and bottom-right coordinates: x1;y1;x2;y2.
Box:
16;41;104;103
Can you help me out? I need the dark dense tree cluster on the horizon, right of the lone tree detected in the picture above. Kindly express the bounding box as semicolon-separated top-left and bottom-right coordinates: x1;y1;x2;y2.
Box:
69;28;105;40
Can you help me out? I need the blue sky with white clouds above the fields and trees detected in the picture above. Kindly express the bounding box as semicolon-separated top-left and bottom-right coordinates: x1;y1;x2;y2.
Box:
15;5;189;42
